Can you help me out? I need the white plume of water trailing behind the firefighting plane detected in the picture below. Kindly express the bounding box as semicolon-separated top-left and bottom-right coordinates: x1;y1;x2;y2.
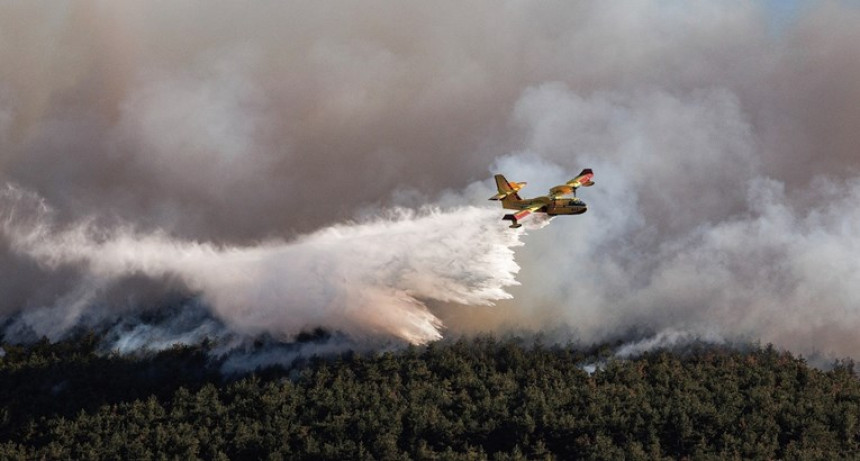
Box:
0;186;520;344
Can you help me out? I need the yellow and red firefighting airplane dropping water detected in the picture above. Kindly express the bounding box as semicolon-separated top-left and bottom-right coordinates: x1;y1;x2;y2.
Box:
490;168;594;228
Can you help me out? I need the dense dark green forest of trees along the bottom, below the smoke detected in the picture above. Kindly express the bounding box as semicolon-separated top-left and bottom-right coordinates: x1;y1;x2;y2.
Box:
0;335;860;459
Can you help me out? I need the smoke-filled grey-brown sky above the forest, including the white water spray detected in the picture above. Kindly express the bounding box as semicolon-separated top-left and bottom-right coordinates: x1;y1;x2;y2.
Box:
0;1;860;362
